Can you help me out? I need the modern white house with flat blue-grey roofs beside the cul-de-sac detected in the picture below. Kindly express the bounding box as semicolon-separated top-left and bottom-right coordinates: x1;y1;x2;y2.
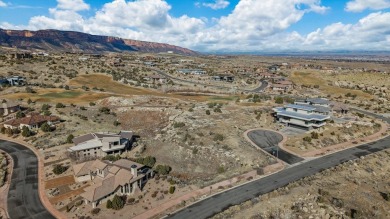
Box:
273;104;330;130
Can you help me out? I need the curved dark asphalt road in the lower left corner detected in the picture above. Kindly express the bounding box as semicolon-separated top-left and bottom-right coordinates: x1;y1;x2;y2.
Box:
0;140;54;219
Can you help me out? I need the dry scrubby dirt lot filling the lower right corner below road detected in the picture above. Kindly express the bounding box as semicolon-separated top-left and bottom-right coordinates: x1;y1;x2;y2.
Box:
214;150;390;219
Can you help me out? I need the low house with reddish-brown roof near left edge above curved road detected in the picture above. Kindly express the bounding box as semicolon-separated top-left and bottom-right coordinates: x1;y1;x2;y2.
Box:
4;113;60;130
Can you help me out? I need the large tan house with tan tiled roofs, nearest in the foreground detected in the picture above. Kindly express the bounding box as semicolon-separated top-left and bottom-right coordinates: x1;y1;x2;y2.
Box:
73;159;153;208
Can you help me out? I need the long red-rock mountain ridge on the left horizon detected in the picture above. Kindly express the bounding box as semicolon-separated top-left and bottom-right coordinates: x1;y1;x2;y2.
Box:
0;29;197;55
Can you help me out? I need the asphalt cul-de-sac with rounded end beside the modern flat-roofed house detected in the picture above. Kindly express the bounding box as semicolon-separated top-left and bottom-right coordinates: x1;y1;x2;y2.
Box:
248;130;303;164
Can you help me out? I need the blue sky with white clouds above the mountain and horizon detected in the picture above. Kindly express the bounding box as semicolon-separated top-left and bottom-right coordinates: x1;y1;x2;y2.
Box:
0;0;390;52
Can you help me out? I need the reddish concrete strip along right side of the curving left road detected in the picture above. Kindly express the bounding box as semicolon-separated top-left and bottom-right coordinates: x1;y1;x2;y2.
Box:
0;135;66;219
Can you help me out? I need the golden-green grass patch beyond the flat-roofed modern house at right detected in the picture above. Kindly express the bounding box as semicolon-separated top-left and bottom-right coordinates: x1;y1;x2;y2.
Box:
290;72;373;99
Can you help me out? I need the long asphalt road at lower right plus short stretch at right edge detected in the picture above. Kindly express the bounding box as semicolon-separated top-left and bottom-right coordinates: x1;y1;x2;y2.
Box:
168;111;390;219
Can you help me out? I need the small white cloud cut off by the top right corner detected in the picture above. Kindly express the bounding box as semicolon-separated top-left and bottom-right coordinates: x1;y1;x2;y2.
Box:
345;0;390;12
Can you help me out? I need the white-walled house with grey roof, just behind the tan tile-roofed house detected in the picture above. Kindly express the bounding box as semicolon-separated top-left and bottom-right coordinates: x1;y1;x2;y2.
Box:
68;131;134;158
